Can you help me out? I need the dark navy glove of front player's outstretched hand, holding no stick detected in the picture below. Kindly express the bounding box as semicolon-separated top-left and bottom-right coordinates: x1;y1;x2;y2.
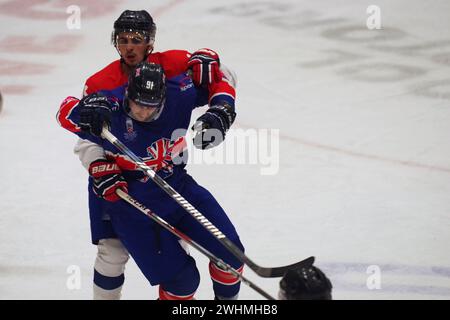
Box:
192;102;236;150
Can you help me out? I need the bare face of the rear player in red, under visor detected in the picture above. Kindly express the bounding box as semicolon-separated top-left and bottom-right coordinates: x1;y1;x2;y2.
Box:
117;32;151;67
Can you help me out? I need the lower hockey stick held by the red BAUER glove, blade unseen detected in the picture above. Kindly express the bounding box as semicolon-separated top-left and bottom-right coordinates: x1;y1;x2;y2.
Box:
116;189;275;300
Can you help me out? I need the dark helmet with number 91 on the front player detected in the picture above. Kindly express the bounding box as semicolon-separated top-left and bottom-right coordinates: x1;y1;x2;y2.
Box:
124;62;166;121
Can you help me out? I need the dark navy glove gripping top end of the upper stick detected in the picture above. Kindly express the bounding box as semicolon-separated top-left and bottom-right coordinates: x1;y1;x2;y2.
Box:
78;93;111;136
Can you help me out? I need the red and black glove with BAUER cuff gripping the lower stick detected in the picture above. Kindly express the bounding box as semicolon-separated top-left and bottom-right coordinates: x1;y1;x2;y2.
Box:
89;159;128;202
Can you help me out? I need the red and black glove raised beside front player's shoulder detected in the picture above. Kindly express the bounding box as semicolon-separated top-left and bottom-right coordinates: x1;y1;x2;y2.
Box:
188;48;222;87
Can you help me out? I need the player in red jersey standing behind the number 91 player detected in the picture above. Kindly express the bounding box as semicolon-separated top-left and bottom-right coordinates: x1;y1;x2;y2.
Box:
58;10;235;299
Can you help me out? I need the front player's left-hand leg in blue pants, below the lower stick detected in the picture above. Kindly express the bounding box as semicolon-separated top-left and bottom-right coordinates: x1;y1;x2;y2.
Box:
111;203;200;300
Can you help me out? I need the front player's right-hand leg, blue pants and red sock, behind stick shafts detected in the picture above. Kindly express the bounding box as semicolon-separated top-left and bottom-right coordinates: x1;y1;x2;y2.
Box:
176;178;244;300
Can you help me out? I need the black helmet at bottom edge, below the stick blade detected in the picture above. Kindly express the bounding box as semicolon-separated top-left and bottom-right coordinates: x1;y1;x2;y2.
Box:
279;265;333;300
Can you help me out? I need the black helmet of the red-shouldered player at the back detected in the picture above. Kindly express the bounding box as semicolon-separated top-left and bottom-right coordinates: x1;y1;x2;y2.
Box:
111;10;156;46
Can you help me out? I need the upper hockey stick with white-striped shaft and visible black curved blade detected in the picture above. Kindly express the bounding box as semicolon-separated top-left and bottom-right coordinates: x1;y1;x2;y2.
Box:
102;126;314;278
